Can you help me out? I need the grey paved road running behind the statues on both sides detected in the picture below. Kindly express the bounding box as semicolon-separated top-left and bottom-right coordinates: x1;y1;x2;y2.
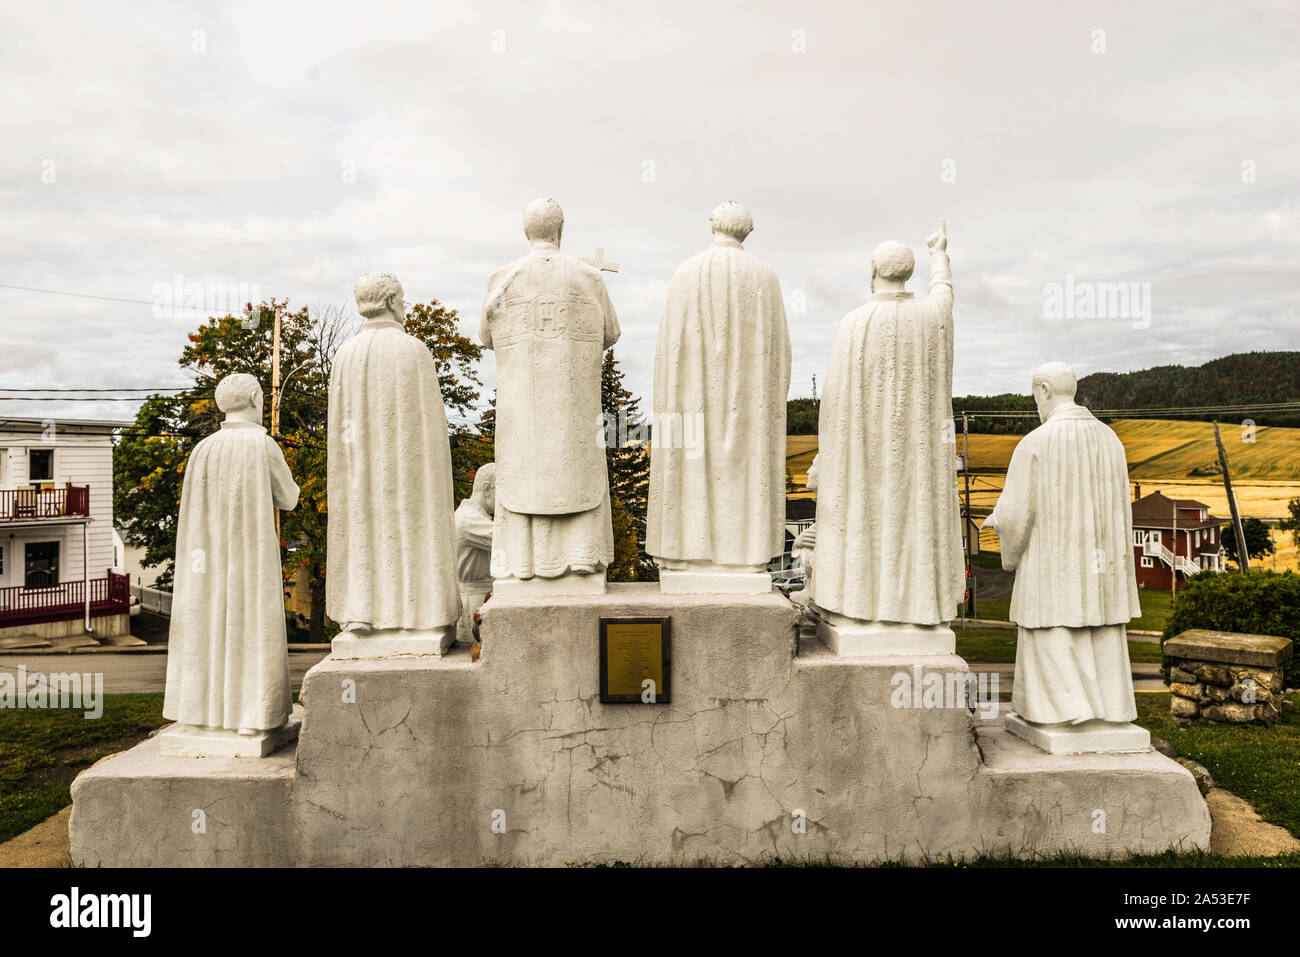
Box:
0;650;1165;694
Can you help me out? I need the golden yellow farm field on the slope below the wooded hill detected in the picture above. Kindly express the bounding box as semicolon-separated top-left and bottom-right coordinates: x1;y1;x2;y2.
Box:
787;419;1300;570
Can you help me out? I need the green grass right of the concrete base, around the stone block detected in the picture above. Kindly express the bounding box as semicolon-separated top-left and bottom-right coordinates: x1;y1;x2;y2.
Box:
1138;693;1300;837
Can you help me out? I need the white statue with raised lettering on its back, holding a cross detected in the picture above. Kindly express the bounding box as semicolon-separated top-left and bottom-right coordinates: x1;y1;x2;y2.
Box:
480;199;619;596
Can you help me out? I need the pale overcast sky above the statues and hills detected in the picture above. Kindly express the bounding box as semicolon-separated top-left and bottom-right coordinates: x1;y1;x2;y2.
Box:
0;0;1300;417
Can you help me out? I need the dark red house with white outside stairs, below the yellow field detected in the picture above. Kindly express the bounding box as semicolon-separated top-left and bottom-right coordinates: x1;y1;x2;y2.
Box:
1132;492;1225;592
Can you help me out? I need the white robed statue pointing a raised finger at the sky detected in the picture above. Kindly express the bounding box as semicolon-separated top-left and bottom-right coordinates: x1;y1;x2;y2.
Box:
813;222;966;654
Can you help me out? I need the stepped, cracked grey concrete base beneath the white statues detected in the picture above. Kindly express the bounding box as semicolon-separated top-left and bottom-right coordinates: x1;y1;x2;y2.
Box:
72;584;1209;866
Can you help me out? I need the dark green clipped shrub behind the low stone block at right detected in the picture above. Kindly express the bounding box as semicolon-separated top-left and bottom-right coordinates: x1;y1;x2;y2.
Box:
1161;571;1300;688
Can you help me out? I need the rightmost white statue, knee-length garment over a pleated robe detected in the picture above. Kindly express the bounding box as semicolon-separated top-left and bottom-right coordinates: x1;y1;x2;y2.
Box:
984;363;1149;752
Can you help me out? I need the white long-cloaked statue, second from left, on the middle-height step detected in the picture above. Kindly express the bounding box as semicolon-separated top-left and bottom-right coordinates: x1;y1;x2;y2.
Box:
325;273;460;658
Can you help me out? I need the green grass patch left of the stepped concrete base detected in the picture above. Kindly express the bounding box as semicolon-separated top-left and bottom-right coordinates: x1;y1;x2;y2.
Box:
0;694;168;841
